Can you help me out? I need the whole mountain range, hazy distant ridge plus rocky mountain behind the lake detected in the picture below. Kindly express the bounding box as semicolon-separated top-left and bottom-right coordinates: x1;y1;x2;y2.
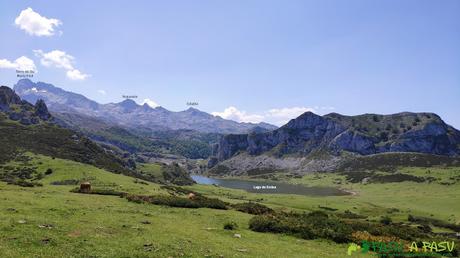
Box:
6;79;460;174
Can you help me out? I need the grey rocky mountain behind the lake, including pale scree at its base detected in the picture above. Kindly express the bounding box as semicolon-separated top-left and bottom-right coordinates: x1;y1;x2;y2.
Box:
208;112;460;173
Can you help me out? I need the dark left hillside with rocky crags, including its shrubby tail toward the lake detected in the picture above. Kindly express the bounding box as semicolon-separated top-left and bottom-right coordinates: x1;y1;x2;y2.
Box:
0;86;194;186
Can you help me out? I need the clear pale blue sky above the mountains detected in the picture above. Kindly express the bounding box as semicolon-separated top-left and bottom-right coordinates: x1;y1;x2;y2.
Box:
0;0;460;128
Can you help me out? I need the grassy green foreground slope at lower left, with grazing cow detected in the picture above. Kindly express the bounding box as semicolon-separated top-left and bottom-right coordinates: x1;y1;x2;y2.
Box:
0;155;347;257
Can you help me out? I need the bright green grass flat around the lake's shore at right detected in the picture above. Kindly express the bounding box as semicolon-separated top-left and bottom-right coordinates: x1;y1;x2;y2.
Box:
188;167;460;227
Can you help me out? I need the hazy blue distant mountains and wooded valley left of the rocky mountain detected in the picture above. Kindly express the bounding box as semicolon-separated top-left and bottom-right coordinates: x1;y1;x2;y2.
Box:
14;79;277;161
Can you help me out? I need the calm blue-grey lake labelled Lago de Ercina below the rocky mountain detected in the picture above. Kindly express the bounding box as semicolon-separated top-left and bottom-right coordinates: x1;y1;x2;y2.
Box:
192;175;349;196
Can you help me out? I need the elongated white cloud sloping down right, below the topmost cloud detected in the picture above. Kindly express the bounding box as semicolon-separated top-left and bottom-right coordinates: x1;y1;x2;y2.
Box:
34;49;91;80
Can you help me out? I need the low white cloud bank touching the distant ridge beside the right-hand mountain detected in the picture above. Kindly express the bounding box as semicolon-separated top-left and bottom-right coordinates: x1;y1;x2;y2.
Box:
211;106;334;126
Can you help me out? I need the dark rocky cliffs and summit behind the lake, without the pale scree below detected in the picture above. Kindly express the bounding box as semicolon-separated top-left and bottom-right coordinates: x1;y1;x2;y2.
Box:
210;112;460;165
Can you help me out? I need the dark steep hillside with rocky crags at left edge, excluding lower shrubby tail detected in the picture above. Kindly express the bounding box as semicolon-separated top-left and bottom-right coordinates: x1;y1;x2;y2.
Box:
0;86;131;174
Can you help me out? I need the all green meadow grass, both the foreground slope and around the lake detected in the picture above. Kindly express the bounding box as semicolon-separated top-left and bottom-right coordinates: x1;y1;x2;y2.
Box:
0;154;460;257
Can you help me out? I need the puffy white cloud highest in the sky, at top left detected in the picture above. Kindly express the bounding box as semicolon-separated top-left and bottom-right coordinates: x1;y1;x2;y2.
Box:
14;7;62;37
